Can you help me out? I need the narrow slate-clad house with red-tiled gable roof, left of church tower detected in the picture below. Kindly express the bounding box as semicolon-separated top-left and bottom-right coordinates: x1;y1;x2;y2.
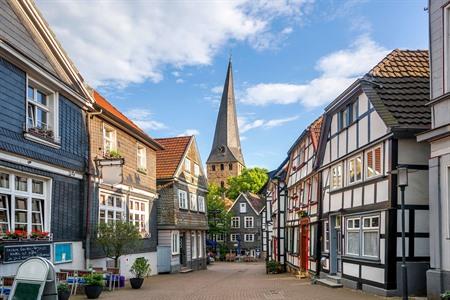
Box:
156;136;208;273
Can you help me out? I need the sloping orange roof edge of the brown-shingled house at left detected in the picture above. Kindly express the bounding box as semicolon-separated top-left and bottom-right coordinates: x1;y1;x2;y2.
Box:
93;90;163;150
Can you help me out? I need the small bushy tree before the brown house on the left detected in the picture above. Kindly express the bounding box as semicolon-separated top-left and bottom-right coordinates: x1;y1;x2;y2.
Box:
96;221;141;268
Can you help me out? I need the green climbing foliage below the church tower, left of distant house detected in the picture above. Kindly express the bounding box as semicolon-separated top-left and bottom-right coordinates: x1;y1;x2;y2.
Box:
206;184;231;239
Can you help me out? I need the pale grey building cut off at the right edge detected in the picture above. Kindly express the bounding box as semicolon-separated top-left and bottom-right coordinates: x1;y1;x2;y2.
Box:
417;0;450;299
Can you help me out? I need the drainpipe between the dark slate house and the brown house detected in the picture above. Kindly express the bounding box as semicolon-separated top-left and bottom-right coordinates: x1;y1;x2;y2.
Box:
84;109;103;270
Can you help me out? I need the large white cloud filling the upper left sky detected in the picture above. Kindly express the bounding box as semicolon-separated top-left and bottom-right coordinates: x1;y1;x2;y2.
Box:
37;0;311;86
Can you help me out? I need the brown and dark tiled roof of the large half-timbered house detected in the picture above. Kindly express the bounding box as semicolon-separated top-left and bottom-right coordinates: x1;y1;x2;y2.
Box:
361;49;431;130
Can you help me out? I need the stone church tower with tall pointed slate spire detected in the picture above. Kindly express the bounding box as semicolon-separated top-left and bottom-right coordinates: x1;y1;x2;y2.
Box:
206;59;245;187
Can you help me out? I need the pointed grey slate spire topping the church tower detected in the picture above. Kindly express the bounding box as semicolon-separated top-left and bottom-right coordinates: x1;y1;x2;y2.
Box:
207;57;244;165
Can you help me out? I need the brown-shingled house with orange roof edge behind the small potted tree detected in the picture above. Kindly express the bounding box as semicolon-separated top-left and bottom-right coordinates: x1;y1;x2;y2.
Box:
87;91;163;277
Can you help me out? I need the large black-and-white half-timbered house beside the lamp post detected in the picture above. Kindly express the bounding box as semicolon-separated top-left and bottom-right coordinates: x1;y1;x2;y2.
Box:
320;50;430;295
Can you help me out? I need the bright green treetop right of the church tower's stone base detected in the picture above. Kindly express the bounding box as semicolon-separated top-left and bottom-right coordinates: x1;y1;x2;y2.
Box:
226;167;268;200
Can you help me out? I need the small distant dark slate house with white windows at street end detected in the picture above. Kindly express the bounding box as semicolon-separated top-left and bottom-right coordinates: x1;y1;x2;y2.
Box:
227;193;265;258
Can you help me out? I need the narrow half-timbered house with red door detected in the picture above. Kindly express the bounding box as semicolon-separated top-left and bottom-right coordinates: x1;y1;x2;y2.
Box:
286;117;322;277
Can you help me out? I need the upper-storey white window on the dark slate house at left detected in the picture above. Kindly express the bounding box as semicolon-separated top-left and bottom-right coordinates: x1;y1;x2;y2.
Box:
25;74;60;143
